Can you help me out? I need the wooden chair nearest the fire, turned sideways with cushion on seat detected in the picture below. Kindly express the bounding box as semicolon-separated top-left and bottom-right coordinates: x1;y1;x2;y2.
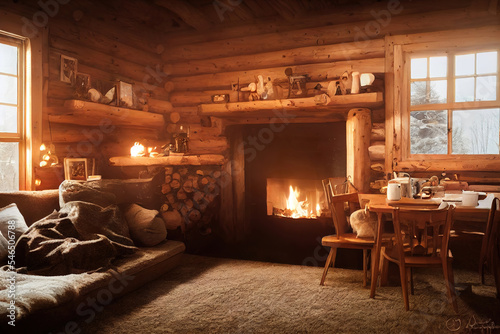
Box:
320;179;375;286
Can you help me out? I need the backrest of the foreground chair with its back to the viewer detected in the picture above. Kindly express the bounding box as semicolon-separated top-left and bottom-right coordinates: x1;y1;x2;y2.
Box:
393;202;454;260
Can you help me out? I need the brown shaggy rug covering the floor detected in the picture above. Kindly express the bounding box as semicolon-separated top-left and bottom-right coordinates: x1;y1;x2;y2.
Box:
47;254;500;334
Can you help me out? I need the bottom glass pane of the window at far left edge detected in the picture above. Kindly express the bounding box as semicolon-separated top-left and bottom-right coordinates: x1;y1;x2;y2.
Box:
0;142;19;191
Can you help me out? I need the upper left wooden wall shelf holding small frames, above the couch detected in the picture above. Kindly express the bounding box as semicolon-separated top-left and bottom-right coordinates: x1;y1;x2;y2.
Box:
49;100;164;129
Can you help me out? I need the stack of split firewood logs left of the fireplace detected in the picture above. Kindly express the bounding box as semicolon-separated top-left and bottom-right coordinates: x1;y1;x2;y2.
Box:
161;166;221;235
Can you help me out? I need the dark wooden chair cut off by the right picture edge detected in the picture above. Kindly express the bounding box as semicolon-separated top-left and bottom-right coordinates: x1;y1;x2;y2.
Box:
479;197;500;284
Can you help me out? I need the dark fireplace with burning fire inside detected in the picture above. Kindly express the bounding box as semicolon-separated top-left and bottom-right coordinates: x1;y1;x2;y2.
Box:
220;122;346;265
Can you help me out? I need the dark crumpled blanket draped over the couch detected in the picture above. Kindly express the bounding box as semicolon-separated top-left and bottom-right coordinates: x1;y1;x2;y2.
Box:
16;201;137;275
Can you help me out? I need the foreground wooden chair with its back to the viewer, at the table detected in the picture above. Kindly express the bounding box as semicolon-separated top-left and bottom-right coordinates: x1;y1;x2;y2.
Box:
381;203;458;312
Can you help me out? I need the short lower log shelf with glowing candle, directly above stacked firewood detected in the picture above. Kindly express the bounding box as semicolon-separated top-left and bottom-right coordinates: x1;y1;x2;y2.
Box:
109;154;224;166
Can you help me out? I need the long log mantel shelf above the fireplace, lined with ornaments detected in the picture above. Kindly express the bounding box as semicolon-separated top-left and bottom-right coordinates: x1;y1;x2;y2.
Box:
198;92;384;117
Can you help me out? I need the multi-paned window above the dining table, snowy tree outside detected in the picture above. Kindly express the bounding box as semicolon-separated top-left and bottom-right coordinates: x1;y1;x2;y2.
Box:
406;49;500;158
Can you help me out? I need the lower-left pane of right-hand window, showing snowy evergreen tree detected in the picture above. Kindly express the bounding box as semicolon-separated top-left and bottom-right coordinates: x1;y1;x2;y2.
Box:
410;110;448;154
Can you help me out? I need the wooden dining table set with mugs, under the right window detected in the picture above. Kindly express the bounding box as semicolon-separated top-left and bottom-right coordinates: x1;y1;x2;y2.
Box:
359;192;500;298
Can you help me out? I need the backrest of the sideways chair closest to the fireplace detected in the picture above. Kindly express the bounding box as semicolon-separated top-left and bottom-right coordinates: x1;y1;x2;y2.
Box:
323;179;360;237
